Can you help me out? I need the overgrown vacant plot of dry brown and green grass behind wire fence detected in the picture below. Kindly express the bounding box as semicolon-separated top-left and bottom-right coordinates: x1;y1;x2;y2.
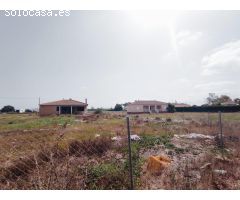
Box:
0;112;240;189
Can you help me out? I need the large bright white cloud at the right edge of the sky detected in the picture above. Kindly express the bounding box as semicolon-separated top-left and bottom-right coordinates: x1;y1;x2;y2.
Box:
202;40;240;78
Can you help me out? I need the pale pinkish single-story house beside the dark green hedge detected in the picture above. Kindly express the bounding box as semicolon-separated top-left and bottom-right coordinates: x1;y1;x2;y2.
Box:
127;100;168;113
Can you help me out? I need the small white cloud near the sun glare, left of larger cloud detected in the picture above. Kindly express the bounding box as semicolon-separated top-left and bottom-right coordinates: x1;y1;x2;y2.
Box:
176;30;203;46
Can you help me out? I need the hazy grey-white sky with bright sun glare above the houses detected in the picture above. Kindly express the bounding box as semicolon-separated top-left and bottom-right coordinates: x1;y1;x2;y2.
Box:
0;11;240;108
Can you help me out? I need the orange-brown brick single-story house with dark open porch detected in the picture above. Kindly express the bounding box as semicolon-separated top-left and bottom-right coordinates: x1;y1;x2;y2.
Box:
39;99;88;116
